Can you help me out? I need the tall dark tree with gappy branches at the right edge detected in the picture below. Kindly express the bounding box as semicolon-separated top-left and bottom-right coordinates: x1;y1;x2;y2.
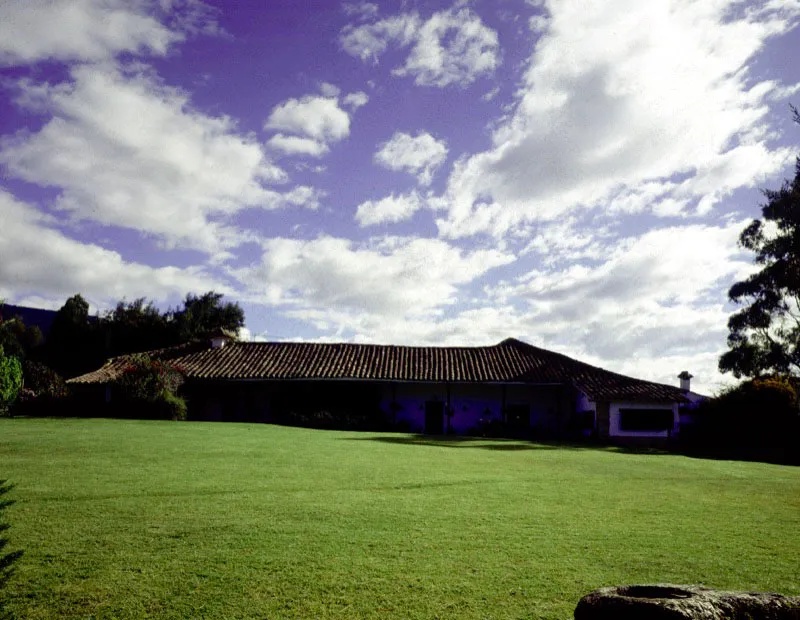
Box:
719;107;800;378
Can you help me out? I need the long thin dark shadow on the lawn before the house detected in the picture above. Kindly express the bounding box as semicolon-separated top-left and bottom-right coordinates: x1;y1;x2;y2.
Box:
342;434;669;454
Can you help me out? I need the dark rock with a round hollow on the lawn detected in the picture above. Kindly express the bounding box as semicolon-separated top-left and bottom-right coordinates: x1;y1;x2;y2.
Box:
575;584;800;620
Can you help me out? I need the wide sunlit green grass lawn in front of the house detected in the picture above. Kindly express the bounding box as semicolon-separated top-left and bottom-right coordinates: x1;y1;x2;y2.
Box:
0;419;800;620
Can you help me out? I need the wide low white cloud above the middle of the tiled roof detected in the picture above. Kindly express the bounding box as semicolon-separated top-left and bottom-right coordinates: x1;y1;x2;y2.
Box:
231;237;513;320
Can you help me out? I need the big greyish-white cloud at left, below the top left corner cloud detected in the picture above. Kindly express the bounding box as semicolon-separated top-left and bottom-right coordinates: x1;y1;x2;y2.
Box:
0;65;306;252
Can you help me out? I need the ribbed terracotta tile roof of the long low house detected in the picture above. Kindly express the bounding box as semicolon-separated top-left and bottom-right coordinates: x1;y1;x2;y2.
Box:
69;338;684;402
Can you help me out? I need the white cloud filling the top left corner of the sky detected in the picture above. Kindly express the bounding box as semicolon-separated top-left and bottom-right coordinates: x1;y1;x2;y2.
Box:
0;0;213;65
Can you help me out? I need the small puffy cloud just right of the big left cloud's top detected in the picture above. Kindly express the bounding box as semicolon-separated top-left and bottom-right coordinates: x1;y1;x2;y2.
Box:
264;89;368;157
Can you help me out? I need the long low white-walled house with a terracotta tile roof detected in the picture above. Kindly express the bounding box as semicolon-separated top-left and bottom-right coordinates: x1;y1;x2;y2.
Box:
69;333;687;439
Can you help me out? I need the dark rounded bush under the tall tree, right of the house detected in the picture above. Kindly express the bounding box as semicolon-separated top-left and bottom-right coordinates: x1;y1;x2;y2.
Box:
687;377;800;463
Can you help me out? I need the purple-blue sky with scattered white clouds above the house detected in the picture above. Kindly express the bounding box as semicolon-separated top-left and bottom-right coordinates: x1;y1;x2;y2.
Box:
0;0;800;393
